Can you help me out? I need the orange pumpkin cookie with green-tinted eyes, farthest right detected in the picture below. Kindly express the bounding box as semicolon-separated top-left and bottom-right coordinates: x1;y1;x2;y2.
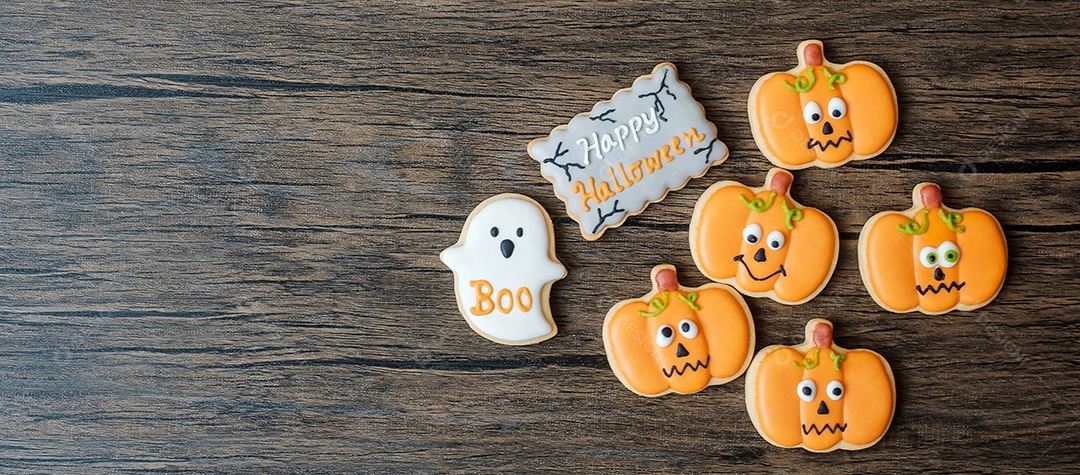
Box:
859;184;1009;315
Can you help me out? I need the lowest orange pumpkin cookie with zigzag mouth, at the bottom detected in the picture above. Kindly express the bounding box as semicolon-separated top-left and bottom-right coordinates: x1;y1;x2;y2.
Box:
746;318;896;452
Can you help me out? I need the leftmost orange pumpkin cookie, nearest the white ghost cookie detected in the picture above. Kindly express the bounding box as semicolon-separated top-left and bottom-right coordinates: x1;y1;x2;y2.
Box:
604;264;754;397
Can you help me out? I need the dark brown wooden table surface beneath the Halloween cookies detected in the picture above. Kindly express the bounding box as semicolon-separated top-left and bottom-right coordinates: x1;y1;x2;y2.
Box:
0;0;1080;473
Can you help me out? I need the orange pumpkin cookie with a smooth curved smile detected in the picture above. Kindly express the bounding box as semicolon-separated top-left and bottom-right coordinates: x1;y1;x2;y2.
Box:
690;168;840;304
